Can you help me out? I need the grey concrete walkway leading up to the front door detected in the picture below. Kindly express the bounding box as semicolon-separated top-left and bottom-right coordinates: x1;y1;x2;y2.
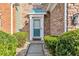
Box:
26;43;44;56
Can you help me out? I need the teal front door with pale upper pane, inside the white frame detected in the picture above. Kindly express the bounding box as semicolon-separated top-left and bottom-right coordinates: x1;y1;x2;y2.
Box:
33;19;41;37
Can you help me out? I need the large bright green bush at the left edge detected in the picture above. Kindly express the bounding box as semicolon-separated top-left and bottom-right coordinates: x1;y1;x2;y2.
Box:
0;31;17;56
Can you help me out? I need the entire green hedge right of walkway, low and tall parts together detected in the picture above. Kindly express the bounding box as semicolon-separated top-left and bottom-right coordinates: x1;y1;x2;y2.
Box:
44;29;79;56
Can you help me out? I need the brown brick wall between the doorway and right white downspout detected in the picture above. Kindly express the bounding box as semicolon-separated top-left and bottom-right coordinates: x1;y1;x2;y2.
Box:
50;3;64;35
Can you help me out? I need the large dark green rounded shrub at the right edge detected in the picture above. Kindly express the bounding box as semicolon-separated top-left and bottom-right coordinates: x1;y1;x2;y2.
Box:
57;29;79;55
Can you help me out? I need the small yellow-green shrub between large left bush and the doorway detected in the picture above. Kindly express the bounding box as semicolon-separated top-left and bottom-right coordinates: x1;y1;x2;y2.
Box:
14;32;27;47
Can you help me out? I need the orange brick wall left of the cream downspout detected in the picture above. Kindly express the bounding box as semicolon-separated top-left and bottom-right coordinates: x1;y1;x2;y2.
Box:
0;3;11;32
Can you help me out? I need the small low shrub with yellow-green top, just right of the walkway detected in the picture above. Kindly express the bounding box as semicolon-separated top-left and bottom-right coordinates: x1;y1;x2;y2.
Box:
44;36;58;55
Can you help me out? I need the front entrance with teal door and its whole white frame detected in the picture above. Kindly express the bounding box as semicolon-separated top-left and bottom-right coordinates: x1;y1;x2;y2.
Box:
29;14;44;40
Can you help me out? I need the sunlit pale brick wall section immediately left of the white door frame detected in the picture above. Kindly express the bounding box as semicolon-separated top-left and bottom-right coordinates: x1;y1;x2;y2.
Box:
20;3;32;31
